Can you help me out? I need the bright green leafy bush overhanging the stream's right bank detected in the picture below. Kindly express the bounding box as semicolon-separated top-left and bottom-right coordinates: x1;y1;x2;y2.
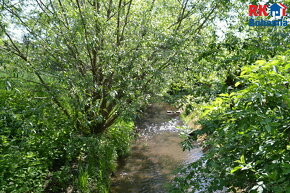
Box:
177;51;290;192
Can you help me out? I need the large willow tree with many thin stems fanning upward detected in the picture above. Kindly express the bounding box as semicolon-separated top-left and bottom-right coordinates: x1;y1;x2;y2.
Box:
0;0;220;134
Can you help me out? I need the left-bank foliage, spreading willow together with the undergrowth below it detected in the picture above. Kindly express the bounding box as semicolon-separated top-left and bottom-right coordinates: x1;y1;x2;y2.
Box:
0;0;222;193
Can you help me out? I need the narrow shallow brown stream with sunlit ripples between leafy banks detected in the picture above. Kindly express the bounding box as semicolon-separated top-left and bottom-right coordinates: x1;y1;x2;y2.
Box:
111;104;202;193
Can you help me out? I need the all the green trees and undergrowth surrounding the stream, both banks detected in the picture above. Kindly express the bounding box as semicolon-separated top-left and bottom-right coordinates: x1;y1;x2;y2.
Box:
0;0;290;193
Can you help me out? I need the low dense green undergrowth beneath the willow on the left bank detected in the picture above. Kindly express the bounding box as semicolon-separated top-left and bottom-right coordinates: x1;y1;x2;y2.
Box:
0;85;134;193
